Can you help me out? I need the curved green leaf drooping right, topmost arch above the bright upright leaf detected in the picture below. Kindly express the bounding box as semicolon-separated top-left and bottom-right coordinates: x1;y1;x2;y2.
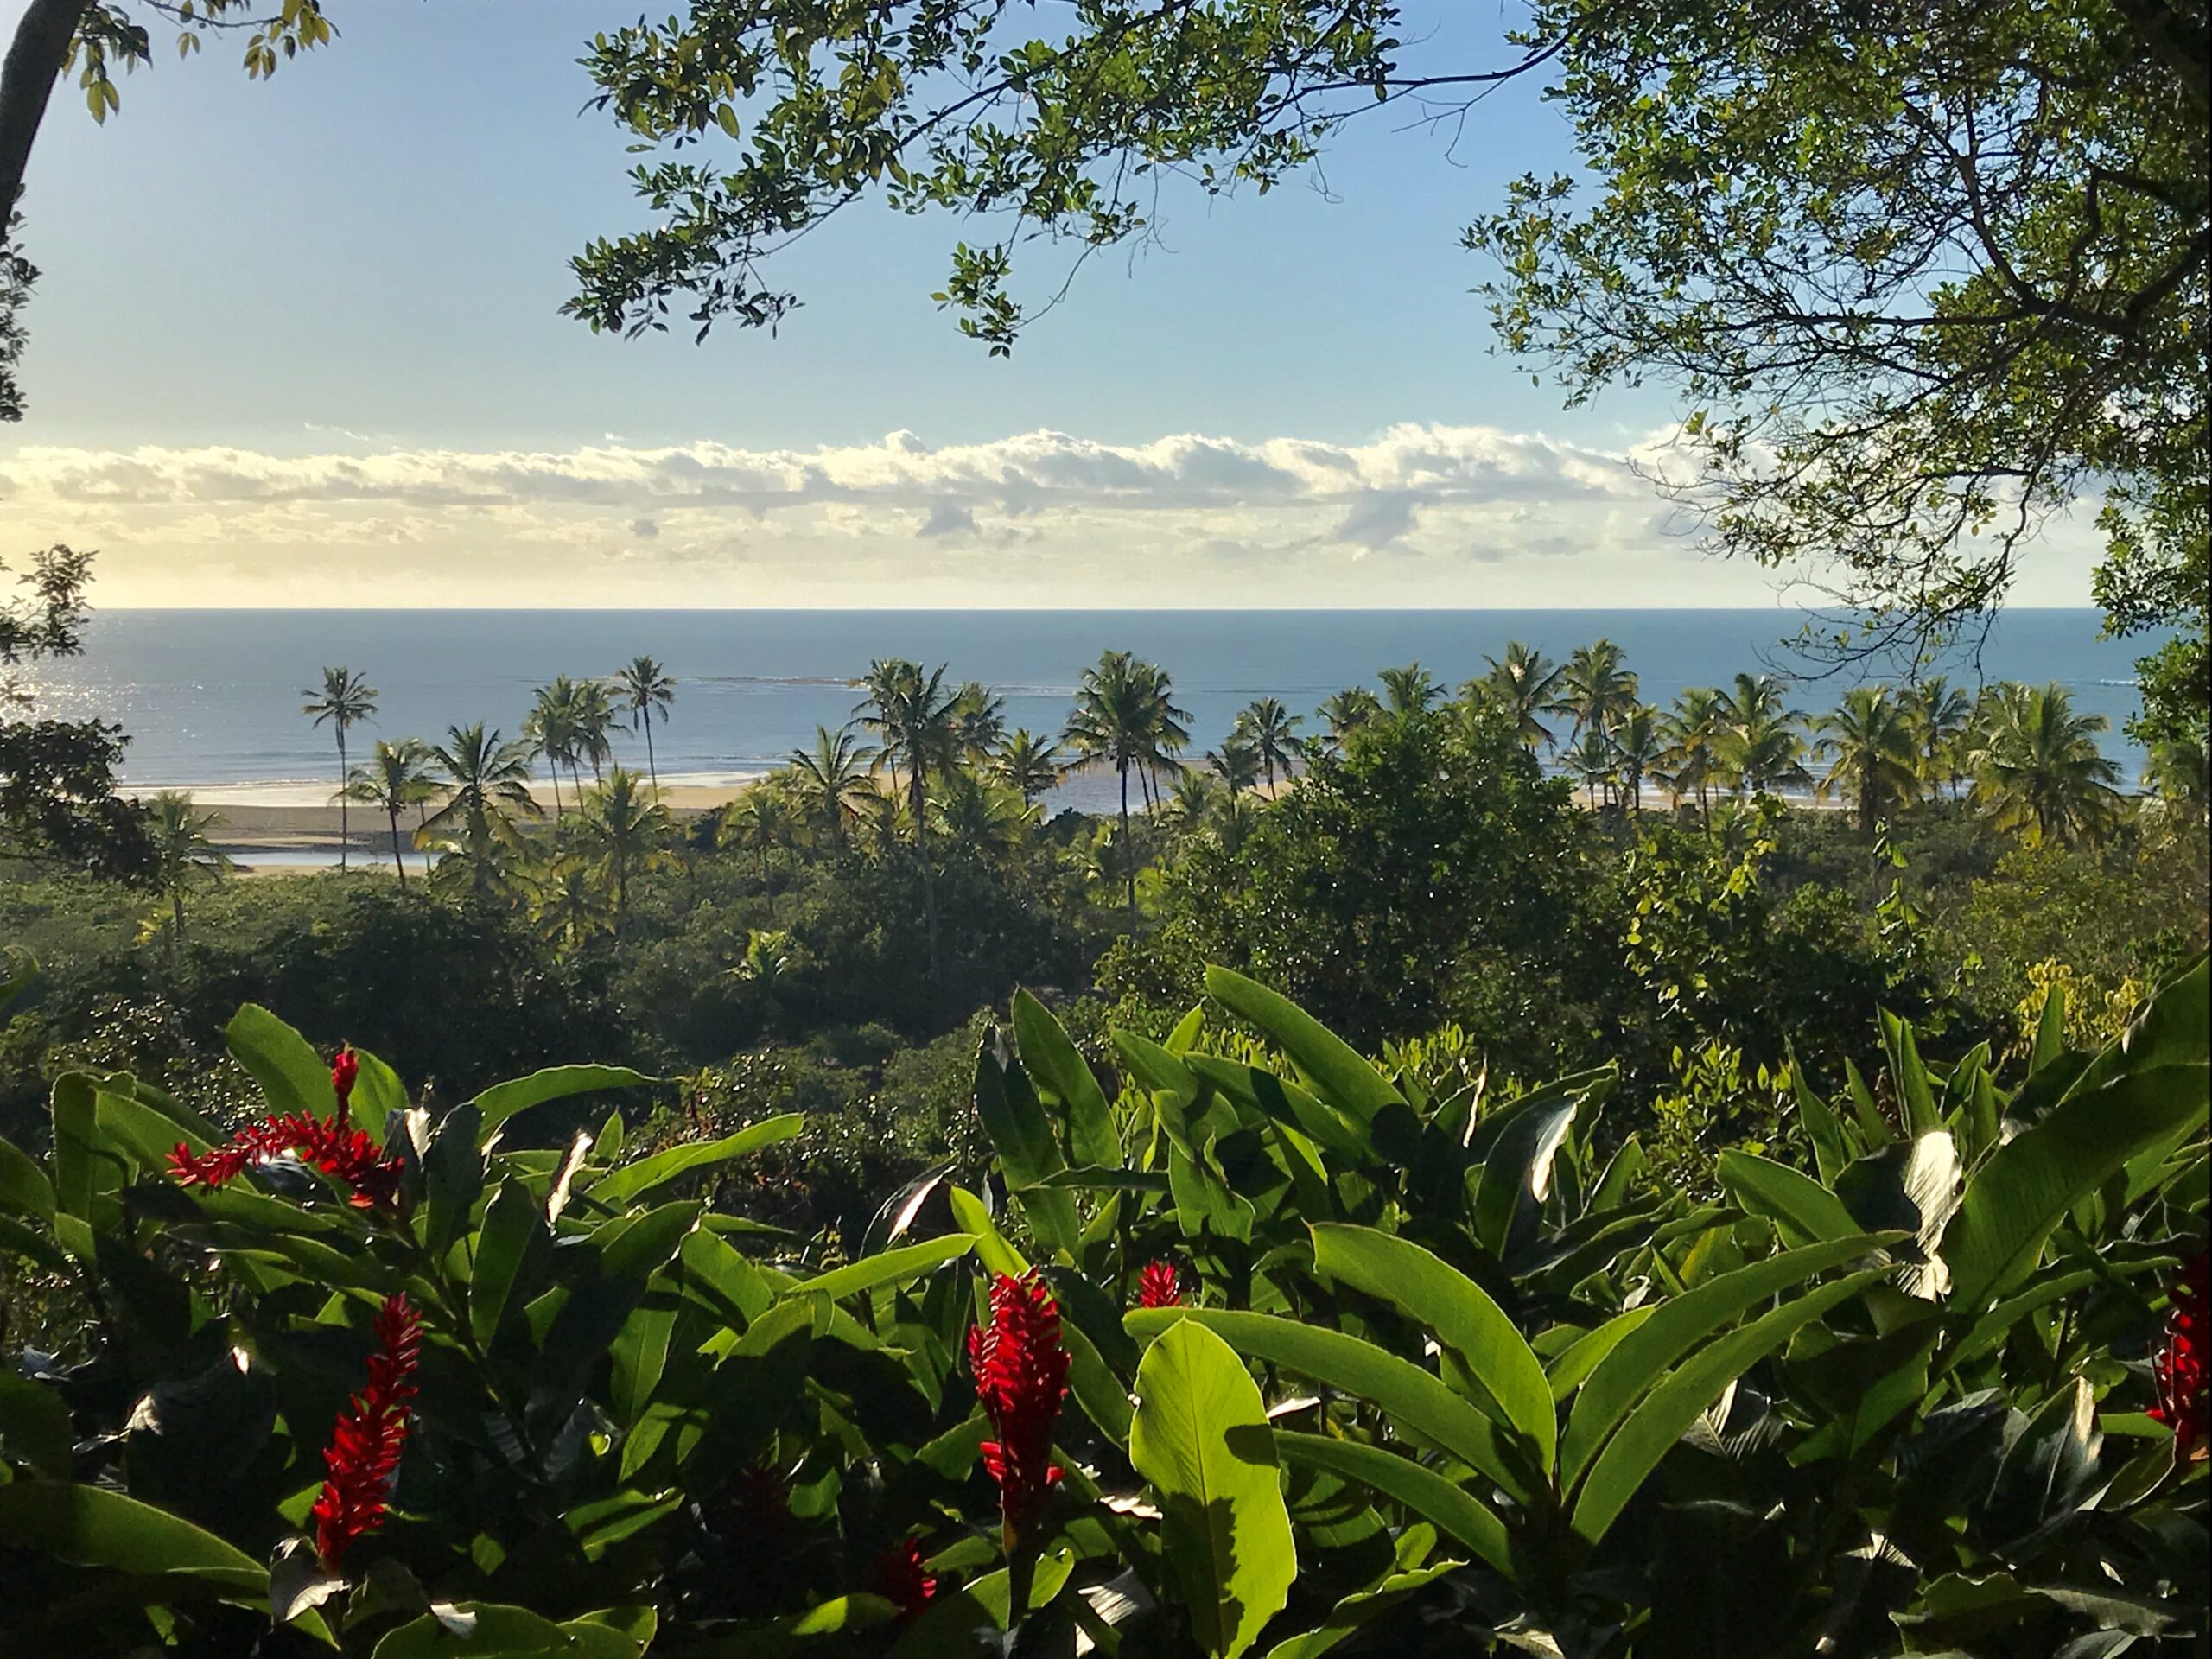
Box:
1312;1224;1560;1476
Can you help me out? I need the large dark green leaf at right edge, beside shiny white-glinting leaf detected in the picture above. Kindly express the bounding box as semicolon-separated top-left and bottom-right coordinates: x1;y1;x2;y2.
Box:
1942;1064;2208;1314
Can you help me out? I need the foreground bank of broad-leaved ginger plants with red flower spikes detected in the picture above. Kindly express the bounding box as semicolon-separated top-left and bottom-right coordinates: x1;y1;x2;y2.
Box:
0;960;2212;1659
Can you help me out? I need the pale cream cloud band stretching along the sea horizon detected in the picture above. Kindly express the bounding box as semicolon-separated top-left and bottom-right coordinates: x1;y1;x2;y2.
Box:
0;425;2088;608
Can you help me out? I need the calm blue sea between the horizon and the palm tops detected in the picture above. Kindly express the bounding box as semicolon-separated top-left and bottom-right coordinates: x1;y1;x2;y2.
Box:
38;611;2141;805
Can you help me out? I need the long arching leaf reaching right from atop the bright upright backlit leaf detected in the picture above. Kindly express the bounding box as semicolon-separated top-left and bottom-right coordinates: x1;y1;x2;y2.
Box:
1123;1307;1537;1504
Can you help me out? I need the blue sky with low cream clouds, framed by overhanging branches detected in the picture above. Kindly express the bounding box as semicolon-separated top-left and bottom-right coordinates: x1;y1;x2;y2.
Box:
0;0;2106;604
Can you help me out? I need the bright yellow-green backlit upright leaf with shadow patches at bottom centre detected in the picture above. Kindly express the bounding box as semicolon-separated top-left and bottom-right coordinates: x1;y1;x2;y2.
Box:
1128;1320;1299;1659
